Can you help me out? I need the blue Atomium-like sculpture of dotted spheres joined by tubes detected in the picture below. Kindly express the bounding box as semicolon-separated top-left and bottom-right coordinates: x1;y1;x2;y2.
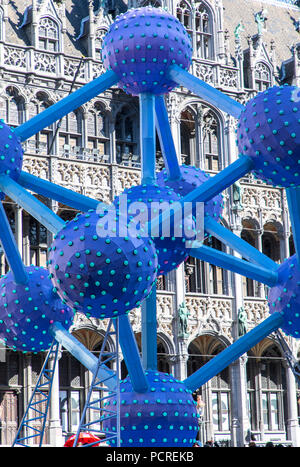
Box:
0;7;300;447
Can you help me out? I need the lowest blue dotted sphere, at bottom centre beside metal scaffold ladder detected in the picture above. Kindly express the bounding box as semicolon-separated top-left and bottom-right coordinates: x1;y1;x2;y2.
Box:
103;370;198;448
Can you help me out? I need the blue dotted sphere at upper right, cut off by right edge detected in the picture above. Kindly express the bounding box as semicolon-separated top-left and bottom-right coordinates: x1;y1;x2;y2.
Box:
237;86;300;187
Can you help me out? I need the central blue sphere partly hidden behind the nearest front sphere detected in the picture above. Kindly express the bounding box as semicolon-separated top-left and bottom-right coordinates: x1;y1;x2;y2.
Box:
114;184;196;275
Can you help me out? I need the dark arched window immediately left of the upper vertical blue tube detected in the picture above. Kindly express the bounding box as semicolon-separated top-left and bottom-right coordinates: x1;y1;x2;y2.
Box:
115;106;140;164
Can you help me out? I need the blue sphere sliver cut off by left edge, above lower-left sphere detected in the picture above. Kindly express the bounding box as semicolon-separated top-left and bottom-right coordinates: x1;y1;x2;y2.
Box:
0;119;23;199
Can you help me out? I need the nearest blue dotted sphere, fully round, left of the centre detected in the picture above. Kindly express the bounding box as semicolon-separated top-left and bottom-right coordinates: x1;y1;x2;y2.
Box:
48;211;157;319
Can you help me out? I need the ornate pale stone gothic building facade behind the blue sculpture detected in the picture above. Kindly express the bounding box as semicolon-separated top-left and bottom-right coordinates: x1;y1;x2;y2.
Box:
0;0;300;446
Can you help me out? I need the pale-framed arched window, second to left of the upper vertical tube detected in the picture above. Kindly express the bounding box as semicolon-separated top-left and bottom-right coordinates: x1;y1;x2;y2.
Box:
87;102;110;162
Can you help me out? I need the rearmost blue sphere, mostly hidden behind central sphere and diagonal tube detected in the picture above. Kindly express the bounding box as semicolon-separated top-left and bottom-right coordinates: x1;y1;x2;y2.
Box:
157;165;224;234
